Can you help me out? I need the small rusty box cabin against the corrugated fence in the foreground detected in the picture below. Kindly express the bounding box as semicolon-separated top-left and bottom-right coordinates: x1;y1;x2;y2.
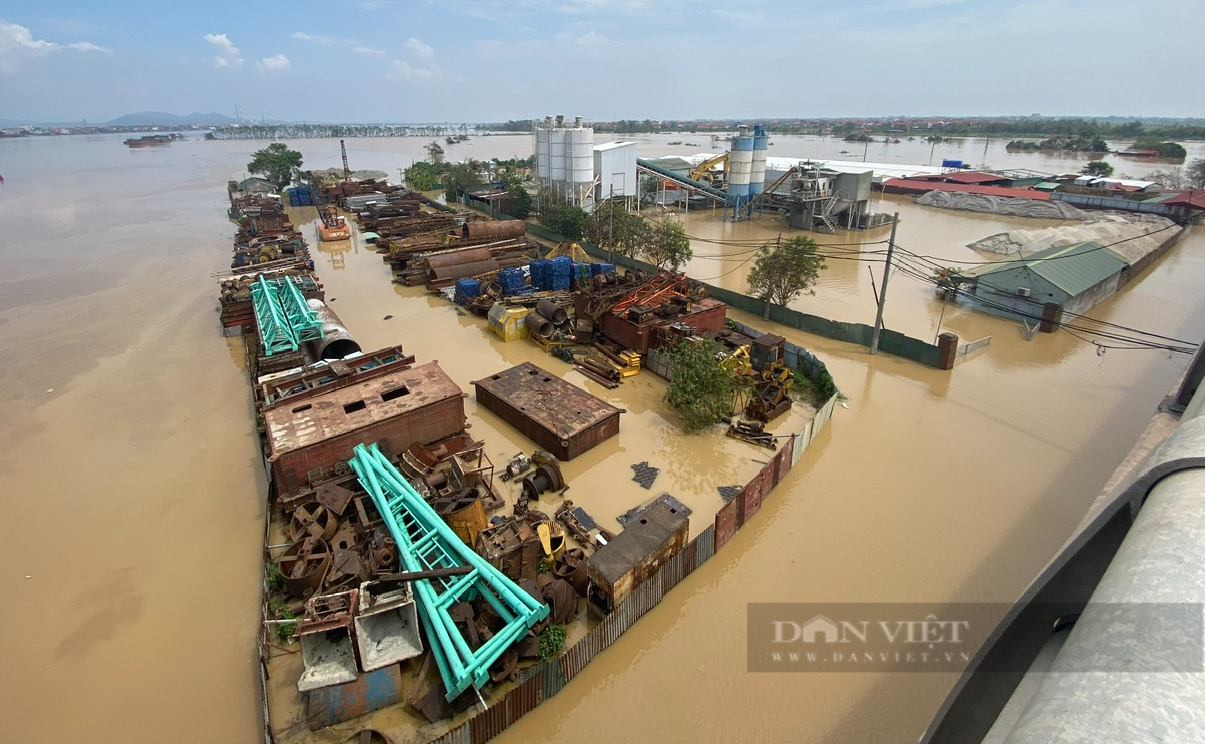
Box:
586;498;690;615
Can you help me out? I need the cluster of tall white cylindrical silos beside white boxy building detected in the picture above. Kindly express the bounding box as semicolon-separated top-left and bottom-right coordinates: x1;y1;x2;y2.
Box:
534;116;595;209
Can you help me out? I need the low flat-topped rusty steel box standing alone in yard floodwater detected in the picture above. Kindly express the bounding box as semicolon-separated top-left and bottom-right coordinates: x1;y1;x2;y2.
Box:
472;362;624;459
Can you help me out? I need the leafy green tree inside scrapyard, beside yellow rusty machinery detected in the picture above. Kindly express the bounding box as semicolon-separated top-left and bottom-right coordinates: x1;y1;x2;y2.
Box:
665;338;735;434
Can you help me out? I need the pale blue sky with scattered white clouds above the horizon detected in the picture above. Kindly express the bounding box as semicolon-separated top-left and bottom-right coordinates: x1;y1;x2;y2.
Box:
0;0;1205;122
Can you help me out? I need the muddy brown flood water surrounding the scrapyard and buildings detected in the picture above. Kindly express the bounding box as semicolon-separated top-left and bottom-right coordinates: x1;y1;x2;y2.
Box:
7;130;1205;744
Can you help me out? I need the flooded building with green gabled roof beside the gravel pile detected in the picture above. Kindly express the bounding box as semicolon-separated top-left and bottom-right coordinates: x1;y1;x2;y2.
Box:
958;241;1130;322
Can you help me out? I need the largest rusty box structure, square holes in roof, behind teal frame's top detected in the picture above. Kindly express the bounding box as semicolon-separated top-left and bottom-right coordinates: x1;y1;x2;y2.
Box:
264;362;465;493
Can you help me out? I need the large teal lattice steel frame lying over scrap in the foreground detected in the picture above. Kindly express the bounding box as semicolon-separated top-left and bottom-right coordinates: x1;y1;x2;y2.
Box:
349;444;548;701
